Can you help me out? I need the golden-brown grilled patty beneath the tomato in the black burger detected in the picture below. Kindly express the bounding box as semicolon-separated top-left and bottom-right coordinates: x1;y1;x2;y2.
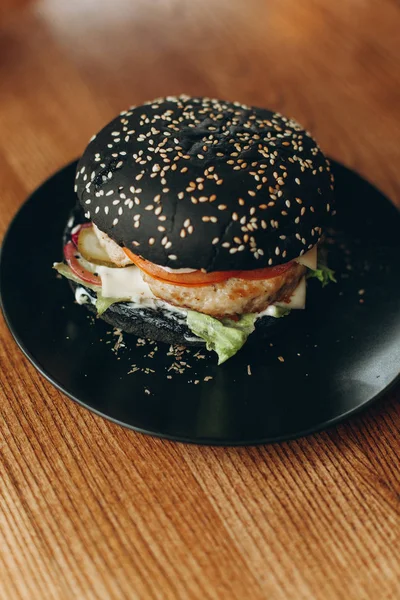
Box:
143;262;306;318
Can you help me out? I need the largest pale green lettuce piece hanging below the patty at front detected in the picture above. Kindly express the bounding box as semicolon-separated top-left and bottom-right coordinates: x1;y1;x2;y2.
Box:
187;310;257;365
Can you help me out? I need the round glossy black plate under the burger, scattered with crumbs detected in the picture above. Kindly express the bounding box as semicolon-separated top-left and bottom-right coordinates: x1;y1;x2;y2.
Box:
0;163;400;445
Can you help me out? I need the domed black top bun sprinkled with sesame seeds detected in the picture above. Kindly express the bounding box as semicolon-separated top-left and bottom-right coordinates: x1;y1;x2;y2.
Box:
75;96;333;271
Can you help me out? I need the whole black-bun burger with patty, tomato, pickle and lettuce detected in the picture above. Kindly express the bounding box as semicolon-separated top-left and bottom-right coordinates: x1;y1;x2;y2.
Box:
54;95;334;363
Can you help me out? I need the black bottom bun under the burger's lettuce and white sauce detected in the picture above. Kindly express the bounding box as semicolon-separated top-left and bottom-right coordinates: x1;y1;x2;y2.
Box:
69;281;292;347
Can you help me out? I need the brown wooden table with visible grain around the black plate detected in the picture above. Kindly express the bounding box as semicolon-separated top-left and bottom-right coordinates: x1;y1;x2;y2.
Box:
0;0;400;600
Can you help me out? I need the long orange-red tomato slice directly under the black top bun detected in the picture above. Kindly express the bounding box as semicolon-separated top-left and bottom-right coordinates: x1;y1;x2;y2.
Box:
123;248;293;287
